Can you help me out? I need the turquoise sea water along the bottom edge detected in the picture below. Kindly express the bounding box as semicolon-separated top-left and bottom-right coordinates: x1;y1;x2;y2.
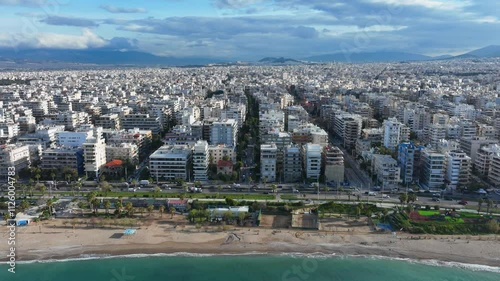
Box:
0;255;500;281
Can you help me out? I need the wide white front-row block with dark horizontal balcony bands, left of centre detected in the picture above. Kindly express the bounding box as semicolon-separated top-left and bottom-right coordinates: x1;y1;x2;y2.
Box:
149;145;192;181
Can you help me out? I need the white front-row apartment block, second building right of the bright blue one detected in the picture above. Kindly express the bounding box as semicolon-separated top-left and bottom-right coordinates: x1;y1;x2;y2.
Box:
446;150;472;189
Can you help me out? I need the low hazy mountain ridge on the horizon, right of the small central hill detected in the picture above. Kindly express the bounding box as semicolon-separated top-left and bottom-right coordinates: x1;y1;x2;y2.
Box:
304;51;432;63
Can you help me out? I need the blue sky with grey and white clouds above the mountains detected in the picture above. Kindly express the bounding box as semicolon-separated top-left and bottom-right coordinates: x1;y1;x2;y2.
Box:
0;0;500;60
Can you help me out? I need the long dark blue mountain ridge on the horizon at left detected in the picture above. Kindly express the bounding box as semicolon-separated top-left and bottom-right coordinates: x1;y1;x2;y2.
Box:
0;49;224;66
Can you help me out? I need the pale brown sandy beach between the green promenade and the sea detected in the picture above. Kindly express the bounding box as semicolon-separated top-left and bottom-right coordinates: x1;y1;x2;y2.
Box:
0;219;500;267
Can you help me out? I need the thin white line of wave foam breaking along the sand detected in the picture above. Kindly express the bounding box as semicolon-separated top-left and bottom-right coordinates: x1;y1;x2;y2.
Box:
9;252;500;273
